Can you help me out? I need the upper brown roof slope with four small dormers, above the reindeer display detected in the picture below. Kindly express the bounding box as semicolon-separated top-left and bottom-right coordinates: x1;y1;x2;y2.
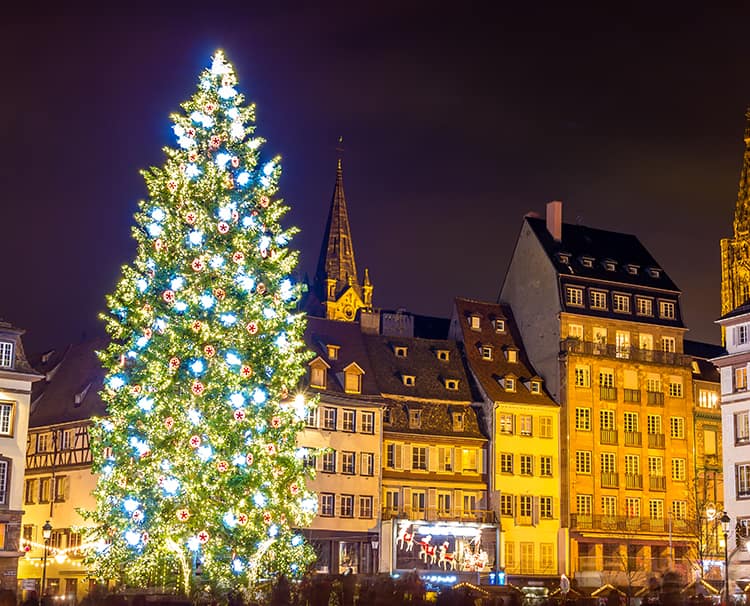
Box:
363;335;474;403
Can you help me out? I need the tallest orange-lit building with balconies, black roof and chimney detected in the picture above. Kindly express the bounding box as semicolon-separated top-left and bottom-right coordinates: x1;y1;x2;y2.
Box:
501;202;697;588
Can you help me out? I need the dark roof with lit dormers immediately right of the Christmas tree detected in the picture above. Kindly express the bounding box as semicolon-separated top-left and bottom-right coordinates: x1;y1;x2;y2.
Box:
305;316;380;400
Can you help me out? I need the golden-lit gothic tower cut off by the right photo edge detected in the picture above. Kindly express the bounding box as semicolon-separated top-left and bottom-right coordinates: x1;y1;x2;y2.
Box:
721;109;750;326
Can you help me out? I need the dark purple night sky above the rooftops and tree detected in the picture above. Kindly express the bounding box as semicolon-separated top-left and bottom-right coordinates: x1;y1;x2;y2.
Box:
0;1;750;351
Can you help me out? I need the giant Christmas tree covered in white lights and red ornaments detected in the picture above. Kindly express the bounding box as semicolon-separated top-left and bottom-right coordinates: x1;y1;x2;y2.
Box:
89;52;317;591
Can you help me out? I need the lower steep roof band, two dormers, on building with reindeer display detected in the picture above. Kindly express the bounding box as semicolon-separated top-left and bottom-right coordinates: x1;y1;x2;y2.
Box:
383;402;486;439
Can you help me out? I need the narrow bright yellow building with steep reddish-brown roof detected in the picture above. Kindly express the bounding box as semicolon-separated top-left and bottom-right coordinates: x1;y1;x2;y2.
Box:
450;299;566;586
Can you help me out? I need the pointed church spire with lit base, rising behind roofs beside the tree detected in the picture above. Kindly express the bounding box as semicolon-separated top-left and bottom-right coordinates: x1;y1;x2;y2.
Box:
308;158;372;322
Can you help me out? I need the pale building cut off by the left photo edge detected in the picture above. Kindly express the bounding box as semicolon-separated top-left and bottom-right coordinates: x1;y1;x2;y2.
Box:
0;321;42;591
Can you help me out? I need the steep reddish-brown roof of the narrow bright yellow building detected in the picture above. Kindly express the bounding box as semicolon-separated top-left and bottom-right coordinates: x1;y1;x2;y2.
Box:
454;298;557;406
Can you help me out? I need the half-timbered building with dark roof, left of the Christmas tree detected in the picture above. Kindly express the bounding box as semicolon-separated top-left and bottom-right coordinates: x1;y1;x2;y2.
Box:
18;341;105;604
